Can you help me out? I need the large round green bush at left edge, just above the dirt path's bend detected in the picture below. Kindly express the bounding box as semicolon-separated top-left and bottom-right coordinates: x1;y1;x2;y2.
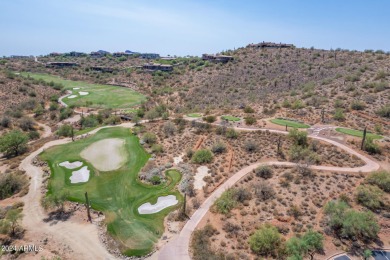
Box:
0;130;28;156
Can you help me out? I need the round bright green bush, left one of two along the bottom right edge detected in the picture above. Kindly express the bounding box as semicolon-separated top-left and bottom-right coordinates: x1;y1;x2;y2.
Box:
249;224;282;257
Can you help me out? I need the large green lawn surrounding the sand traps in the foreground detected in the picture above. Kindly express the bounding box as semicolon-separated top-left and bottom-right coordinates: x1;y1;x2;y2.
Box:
40;127;183;256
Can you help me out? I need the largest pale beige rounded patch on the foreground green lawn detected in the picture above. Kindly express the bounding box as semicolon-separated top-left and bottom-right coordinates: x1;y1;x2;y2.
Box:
80;138;127;171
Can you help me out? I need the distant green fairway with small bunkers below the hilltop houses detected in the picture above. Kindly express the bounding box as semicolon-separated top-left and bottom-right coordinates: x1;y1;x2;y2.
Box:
21;72;146;108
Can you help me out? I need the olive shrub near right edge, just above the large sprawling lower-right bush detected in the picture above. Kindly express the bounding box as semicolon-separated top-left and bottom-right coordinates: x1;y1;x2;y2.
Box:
356;185;384;210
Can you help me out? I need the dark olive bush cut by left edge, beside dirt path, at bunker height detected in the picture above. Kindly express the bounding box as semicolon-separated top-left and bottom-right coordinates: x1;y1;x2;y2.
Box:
0;172;27;200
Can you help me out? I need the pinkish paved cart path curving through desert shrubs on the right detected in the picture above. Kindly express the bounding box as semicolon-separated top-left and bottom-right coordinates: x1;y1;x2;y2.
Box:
158;127;380;260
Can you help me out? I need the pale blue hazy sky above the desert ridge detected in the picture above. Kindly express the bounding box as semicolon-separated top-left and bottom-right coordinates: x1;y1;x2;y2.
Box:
0;0;390;56
